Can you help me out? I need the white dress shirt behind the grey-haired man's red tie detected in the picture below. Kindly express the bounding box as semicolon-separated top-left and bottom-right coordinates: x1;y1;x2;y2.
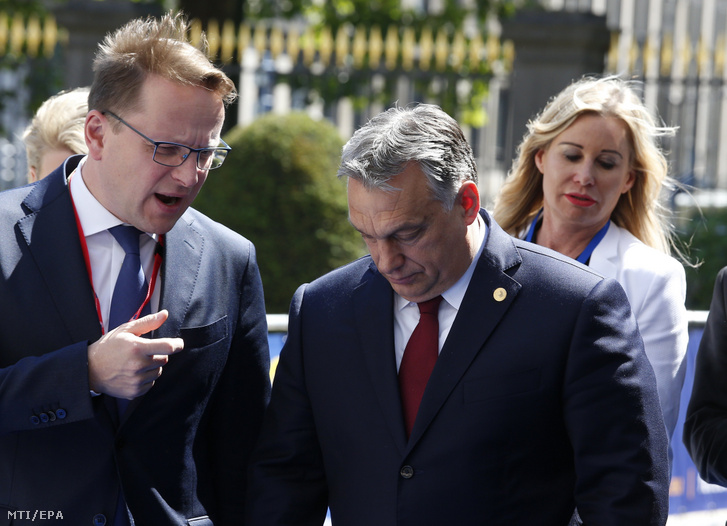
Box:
394;215;487;371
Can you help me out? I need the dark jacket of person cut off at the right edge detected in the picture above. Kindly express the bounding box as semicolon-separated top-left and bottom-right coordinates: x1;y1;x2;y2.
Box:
683;267;727;486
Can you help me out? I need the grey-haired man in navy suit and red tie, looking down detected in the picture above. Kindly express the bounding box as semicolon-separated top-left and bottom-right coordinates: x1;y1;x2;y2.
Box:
247;105;668;526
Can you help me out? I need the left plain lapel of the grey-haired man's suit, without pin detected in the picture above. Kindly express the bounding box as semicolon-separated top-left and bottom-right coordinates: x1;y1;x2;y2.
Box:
353;263;406;452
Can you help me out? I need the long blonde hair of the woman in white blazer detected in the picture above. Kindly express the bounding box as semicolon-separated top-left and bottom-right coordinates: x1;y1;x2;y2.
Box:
493;76;681;256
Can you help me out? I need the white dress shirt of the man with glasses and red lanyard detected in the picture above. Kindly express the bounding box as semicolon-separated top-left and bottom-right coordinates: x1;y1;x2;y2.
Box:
70;157;161;331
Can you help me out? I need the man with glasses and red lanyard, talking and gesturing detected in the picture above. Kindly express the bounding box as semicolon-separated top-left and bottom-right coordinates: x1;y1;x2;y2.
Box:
0;12;270;526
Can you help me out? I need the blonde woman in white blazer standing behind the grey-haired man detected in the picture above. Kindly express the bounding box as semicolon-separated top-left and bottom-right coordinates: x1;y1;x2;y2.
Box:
494;77;688;452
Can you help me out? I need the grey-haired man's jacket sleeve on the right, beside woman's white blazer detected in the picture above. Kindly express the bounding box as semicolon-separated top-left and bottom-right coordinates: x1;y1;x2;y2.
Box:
563;279;669;526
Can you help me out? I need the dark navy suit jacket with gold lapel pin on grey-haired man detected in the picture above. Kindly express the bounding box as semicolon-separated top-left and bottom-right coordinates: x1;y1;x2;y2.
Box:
248;212;669;526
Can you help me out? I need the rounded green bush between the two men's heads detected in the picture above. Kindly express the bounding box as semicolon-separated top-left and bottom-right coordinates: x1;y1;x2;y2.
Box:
195;112;365;313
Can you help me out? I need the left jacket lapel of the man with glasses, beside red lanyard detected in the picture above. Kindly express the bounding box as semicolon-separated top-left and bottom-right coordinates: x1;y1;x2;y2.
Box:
17;156;101;342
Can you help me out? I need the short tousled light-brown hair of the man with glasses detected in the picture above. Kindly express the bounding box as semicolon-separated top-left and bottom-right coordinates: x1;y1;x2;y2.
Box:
88;13;237;117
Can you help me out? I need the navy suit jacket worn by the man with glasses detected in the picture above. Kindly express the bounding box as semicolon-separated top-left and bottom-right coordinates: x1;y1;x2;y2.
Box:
0;157;269;526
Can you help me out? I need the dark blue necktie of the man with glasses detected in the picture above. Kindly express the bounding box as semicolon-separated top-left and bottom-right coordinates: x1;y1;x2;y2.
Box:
109;225;148;330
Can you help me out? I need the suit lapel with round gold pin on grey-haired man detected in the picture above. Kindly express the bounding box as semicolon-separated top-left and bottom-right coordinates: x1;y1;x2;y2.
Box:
408;213;522;448
